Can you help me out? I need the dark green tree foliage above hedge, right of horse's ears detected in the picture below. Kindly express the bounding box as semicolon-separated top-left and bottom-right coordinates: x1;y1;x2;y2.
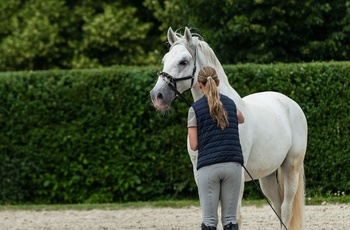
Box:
152;0;350;64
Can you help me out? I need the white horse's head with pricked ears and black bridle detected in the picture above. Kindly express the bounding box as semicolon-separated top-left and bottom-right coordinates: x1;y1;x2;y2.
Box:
150;27;197;110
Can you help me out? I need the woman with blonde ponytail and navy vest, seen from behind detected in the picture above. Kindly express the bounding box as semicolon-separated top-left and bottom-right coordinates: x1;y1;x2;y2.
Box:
188;66;244;230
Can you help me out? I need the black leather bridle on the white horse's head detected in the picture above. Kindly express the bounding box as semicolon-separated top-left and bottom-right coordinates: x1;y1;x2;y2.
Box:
158;49;197;107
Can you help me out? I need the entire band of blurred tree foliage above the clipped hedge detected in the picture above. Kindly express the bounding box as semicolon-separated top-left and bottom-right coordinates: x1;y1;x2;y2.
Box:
0;0;350;71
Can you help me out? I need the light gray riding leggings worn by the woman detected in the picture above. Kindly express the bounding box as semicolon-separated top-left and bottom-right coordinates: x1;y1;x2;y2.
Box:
198;162;242;227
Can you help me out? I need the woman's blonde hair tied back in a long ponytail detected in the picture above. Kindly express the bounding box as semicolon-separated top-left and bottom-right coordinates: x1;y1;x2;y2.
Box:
198;66;228;130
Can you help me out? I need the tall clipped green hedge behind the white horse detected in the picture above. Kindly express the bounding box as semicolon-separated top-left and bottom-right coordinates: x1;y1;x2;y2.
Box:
0;62;350;203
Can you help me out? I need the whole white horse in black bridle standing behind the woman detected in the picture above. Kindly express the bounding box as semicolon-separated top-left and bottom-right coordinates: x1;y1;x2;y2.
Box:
150;27;307;230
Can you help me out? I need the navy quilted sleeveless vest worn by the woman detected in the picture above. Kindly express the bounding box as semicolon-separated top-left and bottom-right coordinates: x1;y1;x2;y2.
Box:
192;94;243;170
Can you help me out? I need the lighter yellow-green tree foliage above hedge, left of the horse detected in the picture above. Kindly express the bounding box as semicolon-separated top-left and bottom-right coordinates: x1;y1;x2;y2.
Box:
0;0;152;70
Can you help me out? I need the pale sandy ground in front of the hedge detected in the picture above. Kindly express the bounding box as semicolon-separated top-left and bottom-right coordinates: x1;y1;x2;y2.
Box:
0;204;350;230
